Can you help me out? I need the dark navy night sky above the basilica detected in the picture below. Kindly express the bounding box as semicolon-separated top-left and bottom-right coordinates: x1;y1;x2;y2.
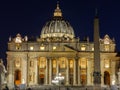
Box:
0;0;120;61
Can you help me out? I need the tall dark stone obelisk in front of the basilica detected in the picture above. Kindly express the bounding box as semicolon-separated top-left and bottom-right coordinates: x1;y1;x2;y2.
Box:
93;10;101;87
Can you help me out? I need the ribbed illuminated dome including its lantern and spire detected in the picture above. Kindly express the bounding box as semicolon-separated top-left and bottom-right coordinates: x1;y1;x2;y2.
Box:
41;4;75;39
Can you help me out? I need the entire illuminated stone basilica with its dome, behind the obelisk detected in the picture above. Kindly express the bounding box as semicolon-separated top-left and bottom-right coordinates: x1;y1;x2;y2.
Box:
6;4;119;87
